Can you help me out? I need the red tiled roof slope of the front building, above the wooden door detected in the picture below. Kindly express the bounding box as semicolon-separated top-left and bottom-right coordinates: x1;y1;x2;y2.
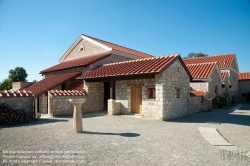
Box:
77;54;188;79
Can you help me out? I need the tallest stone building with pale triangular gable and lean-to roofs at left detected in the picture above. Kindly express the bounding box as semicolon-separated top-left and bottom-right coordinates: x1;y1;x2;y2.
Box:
25;35;152;116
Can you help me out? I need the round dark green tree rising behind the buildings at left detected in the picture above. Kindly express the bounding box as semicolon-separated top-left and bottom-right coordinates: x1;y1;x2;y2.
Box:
9;67;28;82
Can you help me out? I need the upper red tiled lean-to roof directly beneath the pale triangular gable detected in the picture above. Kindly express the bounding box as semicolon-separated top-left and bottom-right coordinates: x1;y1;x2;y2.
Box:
40;53;110;74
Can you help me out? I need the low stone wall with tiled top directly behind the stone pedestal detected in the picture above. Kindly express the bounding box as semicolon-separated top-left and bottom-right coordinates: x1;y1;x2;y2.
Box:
48;96;85;116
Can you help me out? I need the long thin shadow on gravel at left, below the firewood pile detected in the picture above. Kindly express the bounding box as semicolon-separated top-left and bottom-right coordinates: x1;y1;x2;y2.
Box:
0;118;68;129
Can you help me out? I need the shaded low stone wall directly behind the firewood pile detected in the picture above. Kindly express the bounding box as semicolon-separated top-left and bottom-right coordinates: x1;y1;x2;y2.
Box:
0;97;34;117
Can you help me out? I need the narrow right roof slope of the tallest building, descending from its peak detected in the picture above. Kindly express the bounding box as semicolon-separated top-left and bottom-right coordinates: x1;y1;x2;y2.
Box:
84;35;152;58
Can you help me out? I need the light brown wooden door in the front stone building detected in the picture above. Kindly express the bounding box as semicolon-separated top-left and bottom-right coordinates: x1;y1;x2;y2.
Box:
131;86;142;114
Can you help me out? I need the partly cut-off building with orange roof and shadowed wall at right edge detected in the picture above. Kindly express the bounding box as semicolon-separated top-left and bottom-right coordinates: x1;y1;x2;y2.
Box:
239;72;250;101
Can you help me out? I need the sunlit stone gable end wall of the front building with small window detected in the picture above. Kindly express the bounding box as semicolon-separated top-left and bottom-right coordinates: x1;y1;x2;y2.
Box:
156;60;190;120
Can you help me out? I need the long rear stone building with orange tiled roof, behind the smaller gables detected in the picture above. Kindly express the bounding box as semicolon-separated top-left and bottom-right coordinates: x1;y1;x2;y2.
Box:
183;54;239;97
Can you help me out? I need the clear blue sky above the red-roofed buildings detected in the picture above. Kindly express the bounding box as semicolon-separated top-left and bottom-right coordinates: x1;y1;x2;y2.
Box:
0;0;250;81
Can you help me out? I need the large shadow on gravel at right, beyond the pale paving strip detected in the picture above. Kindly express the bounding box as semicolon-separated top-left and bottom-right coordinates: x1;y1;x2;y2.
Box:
168;104;250;126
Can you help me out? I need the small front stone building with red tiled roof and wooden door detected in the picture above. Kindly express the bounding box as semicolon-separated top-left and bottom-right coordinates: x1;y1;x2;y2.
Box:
77;54;192;120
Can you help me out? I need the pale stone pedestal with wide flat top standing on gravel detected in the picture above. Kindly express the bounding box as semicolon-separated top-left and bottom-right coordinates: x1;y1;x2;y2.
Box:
69;99;86;133
